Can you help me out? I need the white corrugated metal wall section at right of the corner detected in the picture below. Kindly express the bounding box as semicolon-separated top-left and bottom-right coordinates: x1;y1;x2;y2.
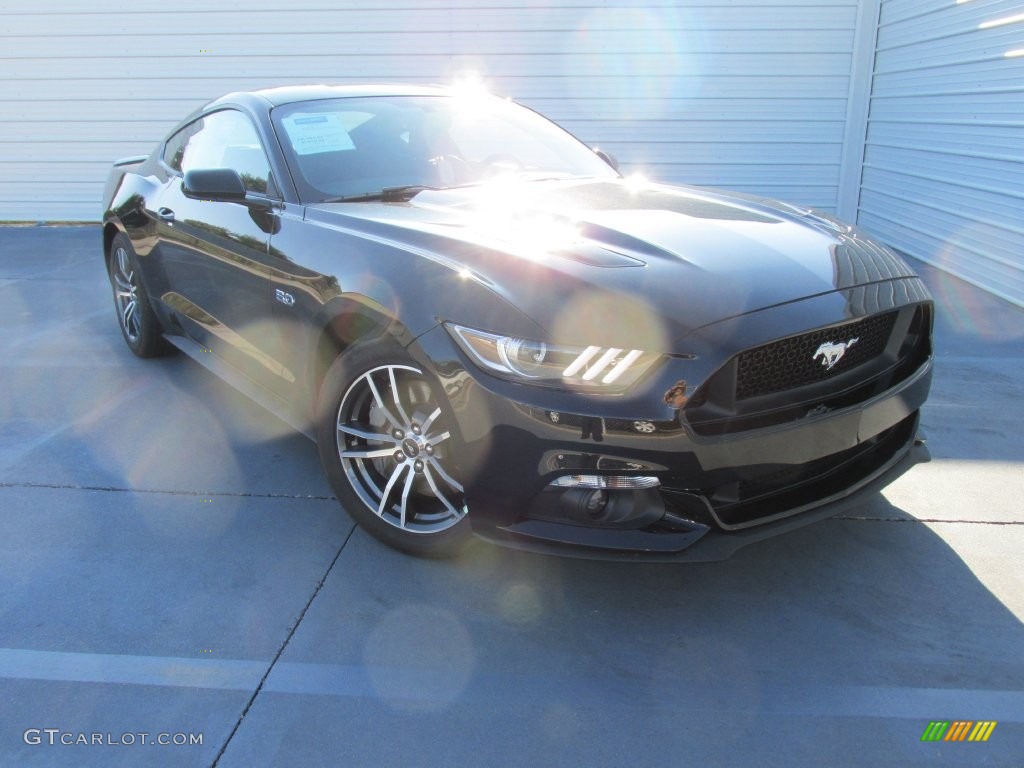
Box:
858;0;1024;305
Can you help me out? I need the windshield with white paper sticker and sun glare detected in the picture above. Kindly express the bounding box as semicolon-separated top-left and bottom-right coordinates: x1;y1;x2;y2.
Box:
272;95;617;203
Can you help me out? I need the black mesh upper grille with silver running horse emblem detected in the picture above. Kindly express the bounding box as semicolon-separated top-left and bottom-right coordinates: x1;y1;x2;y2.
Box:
736;312;896;400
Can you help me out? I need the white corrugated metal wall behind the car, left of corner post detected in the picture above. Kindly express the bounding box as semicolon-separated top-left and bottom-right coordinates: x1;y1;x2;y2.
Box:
0;0;860;220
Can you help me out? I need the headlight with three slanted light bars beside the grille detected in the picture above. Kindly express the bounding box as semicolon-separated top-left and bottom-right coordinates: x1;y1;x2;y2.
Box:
445;324;660;392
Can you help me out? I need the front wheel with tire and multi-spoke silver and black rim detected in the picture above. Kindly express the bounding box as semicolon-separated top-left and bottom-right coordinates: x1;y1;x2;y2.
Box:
316;339;470;557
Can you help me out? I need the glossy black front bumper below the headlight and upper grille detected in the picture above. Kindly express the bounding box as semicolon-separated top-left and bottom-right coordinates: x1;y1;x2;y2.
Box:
409;303;932;561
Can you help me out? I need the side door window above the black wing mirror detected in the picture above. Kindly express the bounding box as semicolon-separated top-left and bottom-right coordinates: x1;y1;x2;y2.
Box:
164;110;272;195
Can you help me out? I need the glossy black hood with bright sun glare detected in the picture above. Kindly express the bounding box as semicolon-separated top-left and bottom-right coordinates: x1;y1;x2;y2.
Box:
301;180;912;349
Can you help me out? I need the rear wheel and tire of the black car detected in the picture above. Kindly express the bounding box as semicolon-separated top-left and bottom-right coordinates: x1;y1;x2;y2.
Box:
106;232;172;357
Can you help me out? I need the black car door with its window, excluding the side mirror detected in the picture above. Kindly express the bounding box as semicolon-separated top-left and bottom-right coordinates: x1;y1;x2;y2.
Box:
155;110;290;389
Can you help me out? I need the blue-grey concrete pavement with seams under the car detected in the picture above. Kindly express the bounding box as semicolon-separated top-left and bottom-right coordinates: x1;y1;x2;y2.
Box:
0;226;1024;767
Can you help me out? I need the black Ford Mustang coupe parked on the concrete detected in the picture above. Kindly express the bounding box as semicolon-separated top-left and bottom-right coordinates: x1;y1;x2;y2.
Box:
103;86;933;560
